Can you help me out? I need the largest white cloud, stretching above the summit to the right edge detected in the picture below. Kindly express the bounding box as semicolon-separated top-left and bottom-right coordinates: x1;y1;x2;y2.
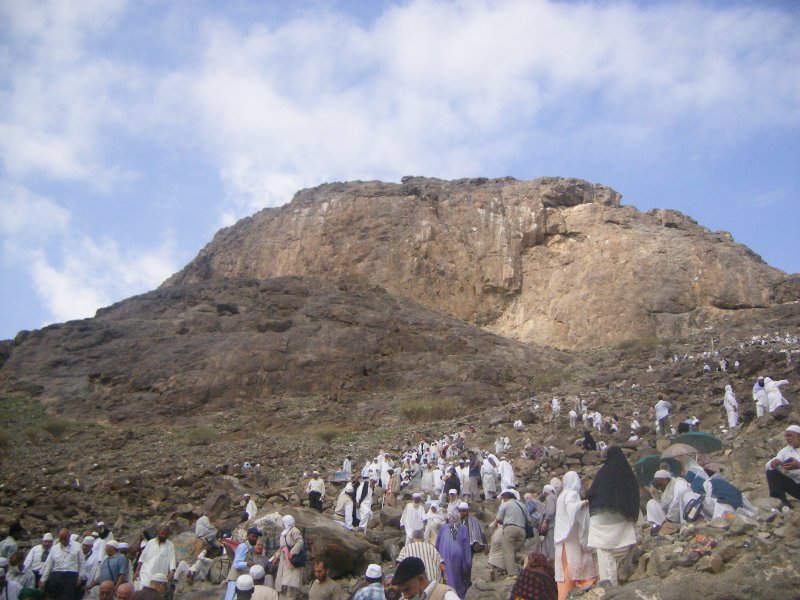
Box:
147;0;800;223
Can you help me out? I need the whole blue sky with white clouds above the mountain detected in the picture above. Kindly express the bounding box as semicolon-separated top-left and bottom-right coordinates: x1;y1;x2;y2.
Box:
0;0;800;339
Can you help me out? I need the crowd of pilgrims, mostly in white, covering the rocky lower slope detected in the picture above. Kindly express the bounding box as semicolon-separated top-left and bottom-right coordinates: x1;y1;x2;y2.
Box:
0;378;800;600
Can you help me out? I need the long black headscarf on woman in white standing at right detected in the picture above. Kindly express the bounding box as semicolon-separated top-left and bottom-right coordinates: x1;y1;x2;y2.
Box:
586;446;640;521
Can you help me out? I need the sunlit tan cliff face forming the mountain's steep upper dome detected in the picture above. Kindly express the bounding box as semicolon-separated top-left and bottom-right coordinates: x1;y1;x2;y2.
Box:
164;177;796;349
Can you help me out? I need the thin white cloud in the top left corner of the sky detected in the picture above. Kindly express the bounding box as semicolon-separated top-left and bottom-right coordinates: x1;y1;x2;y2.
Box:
0;0;137;187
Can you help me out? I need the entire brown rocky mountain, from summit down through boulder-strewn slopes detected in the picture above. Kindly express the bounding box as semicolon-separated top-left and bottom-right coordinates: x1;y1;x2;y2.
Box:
0;178;800;600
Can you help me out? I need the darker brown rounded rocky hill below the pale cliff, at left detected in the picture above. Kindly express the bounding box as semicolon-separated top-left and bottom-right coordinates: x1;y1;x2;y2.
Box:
0;277;574;427
